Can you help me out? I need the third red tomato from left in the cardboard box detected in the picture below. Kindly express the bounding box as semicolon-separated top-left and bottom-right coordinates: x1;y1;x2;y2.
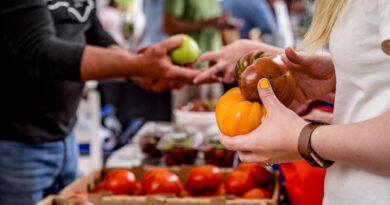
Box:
184;165;222;195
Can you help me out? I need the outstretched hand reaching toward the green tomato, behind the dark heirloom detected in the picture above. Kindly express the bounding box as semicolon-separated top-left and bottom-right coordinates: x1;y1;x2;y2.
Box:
194;40;283;84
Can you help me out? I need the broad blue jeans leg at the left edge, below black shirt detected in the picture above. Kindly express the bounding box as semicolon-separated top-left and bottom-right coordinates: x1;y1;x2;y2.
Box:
0;141;64;205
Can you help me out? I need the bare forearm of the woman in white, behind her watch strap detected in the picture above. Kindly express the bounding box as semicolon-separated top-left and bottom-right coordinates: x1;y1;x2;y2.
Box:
311;112;390;175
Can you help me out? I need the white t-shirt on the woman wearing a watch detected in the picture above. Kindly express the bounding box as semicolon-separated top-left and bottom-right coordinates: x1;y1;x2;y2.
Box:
323;0;390;205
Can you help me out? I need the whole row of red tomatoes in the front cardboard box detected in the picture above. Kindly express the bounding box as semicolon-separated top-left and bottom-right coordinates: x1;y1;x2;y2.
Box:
94;164;273;199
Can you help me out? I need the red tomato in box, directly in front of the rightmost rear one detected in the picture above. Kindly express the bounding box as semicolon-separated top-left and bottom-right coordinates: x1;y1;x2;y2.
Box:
225;171;255;195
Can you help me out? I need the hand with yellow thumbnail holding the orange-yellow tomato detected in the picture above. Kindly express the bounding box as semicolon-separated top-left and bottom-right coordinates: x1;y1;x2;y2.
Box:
220;79;307;163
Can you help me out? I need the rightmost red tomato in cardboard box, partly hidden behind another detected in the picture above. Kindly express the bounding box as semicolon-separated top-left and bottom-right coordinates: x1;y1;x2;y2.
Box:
236;163;273;188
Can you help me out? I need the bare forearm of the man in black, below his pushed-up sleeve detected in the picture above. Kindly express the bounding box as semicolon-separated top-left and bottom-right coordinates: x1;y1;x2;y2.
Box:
80;45;140;81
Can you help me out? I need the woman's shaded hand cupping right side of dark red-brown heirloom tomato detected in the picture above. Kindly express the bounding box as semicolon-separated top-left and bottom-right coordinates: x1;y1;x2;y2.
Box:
283;47;336;110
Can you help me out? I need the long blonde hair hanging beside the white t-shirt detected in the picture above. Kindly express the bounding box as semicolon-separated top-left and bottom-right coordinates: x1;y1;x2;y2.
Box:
298;0;347;52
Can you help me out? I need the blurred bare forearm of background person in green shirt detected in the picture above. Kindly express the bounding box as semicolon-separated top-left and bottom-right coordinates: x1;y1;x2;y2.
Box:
163;14;214;35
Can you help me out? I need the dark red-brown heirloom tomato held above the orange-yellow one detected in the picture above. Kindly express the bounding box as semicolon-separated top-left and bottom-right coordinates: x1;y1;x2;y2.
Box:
235;51;296;106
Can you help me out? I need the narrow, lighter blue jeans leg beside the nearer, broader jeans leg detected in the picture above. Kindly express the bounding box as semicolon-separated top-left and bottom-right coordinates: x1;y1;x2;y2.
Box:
45;132;79;195
